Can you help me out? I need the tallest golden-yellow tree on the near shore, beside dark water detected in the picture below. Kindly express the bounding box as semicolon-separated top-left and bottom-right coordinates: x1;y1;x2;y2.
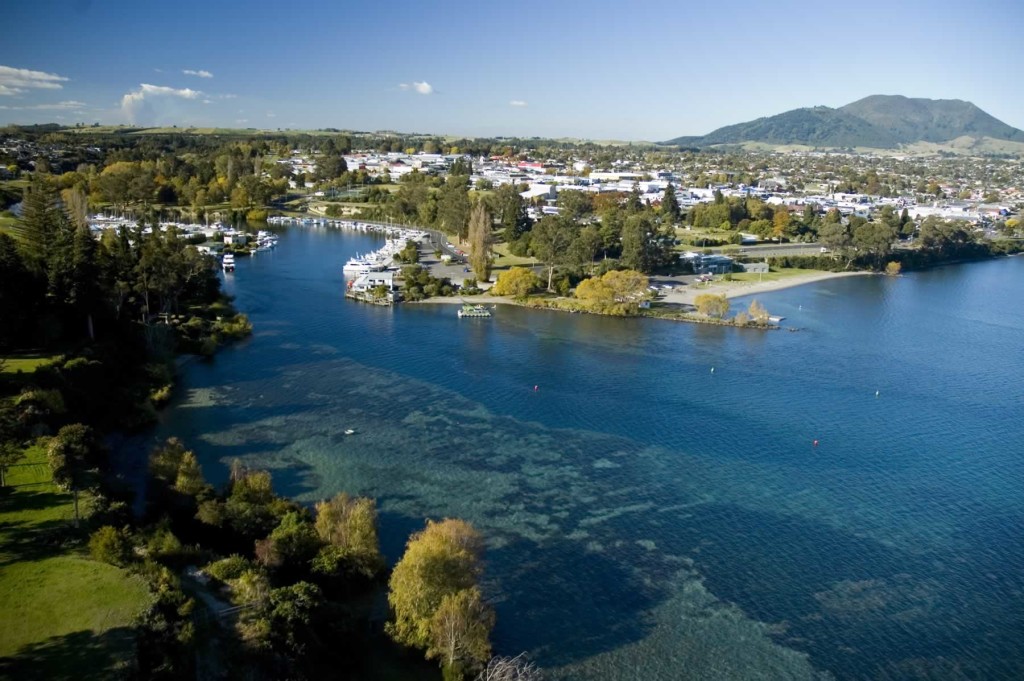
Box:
386;518;483;650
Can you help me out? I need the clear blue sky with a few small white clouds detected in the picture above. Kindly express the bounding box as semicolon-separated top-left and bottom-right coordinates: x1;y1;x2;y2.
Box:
0;0;1024;140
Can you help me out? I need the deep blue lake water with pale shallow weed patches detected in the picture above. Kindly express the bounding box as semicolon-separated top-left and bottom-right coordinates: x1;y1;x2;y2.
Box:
146;229;1024;679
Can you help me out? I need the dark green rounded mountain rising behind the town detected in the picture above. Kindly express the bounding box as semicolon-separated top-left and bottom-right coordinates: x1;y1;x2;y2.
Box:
664;94;1024;148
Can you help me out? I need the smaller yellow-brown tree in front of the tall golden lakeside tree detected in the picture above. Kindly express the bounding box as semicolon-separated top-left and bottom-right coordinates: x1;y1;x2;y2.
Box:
427;587;495;672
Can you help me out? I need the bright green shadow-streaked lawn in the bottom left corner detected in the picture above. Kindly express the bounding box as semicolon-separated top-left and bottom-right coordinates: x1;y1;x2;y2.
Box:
0;448;150;679
